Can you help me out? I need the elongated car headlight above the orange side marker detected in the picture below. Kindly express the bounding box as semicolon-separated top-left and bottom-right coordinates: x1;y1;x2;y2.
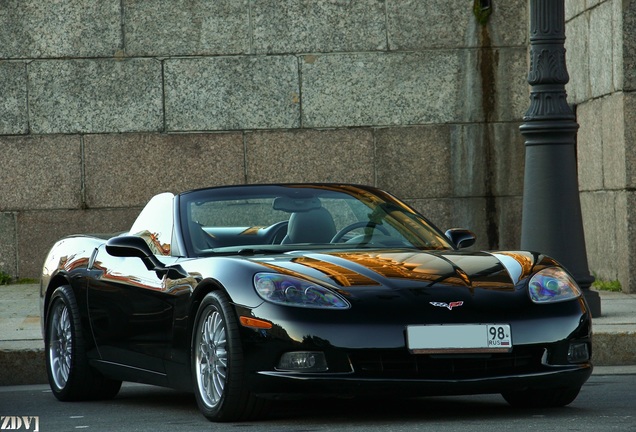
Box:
254;273;350;309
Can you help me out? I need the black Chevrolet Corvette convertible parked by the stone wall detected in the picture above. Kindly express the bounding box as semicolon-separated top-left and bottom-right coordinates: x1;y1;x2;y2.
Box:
41;184;592;421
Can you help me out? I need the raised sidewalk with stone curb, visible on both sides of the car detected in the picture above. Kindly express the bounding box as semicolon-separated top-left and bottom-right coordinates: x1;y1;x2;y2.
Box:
0;285;636;386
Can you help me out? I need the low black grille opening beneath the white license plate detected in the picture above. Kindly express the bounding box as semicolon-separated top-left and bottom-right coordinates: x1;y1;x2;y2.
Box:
349;348;544;379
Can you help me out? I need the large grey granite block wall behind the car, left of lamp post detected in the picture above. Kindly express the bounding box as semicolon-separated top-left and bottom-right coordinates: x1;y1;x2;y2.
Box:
0;0;528;277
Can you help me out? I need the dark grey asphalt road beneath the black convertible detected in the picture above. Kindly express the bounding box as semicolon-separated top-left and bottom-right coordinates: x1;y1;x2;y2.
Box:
0;375;636;432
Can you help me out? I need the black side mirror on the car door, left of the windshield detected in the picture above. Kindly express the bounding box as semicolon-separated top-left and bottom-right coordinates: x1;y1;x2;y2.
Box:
106;236;189;279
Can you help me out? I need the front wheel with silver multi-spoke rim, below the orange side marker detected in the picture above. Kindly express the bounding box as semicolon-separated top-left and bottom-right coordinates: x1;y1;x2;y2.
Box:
191;291;266;421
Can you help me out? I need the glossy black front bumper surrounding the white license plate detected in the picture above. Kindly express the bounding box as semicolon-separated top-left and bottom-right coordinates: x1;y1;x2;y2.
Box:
243;294;593;397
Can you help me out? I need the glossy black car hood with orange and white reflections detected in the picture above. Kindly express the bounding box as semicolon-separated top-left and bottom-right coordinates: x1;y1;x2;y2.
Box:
251;249;542;291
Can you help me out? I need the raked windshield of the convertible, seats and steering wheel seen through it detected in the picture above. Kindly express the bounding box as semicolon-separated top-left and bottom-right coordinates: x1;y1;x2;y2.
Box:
179;184;452;256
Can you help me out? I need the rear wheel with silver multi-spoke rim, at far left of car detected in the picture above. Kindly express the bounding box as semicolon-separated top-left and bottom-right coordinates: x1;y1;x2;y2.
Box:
44;286;121;401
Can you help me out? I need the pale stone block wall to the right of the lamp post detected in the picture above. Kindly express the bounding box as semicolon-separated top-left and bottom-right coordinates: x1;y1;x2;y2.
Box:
566;0;636;293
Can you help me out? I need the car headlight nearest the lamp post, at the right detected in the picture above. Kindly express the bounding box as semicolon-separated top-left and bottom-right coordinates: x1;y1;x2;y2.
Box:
528;267;581;303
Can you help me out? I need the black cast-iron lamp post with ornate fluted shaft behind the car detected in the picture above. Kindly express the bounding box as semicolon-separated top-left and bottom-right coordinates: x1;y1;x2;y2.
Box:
520;0;601;316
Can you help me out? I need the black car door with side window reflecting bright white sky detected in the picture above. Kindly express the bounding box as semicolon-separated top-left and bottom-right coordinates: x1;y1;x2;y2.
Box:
87;194;184;373
